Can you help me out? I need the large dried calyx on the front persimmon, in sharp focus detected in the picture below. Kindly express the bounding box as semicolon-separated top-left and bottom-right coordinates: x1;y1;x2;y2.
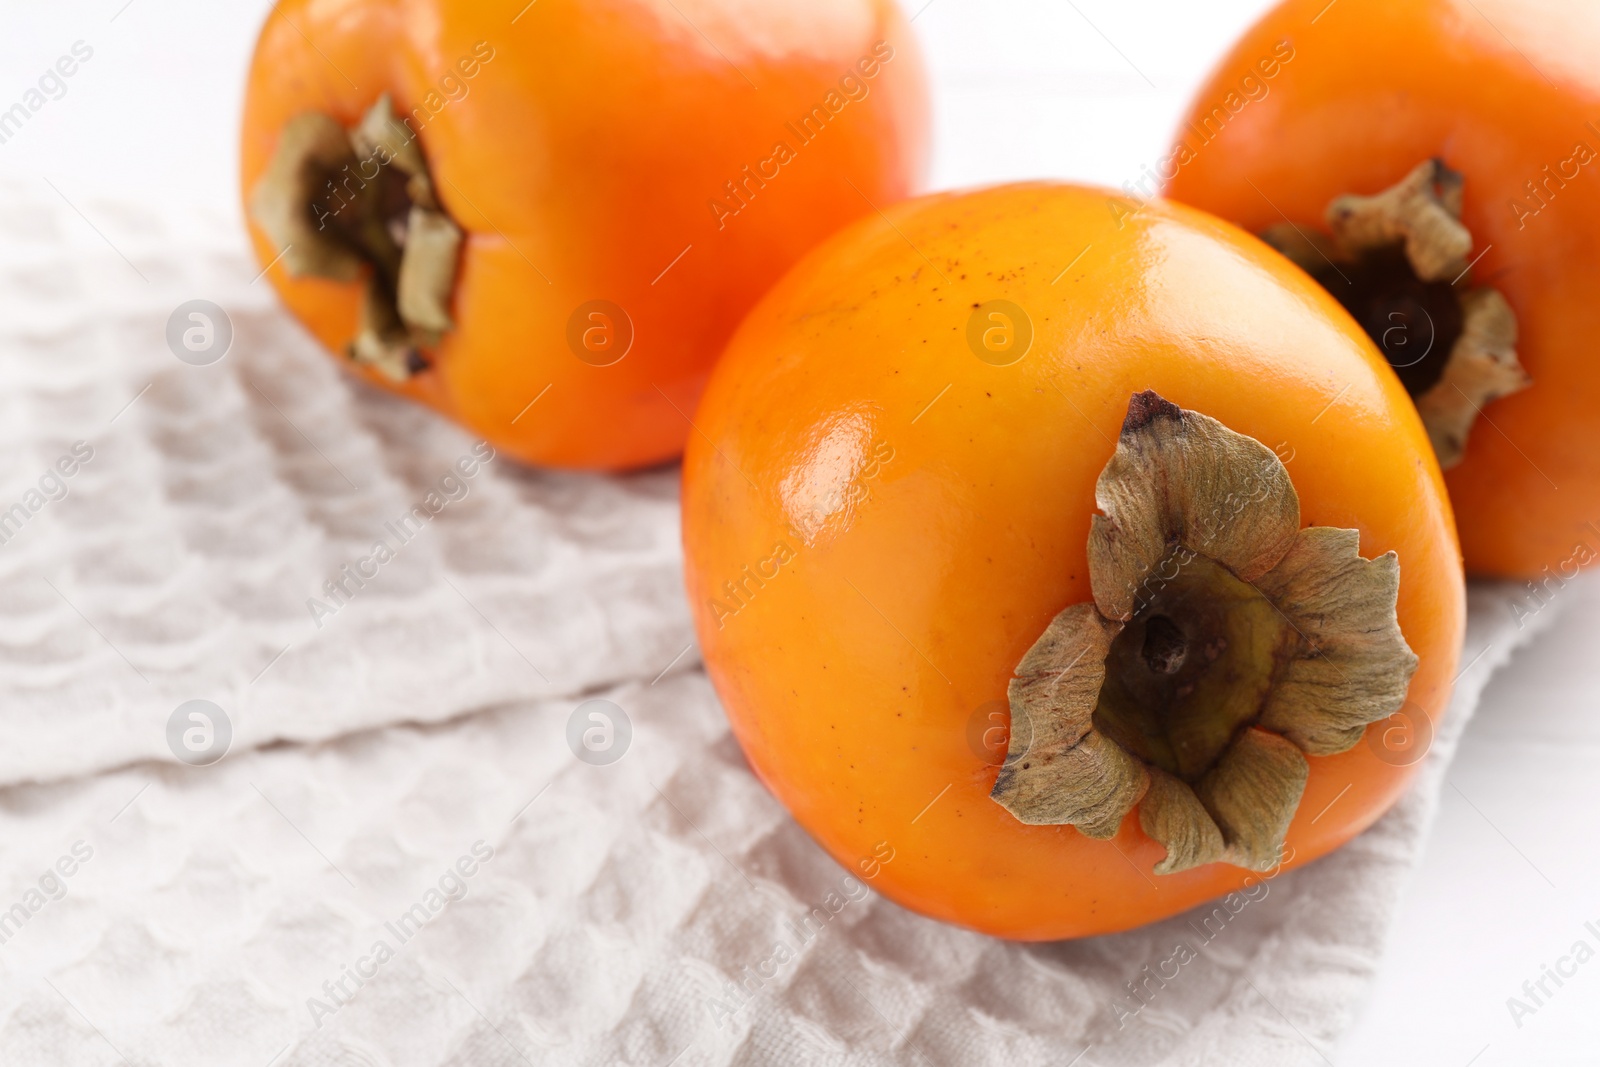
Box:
990;392;1418;873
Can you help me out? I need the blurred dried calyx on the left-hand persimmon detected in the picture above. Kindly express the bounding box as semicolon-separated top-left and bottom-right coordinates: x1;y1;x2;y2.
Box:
250;94;461;381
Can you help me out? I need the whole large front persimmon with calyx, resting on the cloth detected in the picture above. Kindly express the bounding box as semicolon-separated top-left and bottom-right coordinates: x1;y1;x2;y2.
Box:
683;184;1462;939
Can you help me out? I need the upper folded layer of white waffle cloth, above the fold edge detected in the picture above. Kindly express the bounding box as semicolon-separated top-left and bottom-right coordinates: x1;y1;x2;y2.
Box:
0;177;693;782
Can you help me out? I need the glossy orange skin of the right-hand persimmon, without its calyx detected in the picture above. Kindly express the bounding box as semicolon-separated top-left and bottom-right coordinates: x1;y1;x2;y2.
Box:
1155;0;1600;577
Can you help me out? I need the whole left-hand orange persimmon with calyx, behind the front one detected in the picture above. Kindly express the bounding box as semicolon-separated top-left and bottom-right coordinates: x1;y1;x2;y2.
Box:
240;0;928;469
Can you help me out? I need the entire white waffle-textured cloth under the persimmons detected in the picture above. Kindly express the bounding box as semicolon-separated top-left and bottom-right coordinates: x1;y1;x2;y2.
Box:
0;179;1550;1067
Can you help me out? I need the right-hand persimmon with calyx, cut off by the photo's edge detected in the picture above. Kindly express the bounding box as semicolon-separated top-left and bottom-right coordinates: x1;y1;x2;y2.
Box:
1155;0;1600;582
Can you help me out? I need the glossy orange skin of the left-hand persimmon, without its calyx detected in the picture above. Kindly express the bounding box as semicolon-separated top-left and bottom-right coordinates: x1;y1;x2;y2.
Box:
240;0;928;469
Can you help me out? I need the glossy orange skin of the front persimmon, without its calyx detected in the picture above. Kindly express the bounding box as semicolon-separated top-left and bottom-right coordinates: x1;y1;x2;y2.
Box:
683;184;1464;939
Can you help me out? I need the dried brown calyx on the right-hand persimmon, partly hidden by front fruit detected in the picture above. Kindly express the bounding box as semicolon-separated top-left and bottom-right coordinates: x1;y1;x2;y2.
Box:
1261;160;1531;469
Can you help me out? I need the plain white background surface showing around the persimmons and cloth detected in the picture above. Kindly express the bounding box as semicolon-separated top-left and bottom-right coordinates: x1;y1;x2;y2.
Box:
0;0;1600;1067
